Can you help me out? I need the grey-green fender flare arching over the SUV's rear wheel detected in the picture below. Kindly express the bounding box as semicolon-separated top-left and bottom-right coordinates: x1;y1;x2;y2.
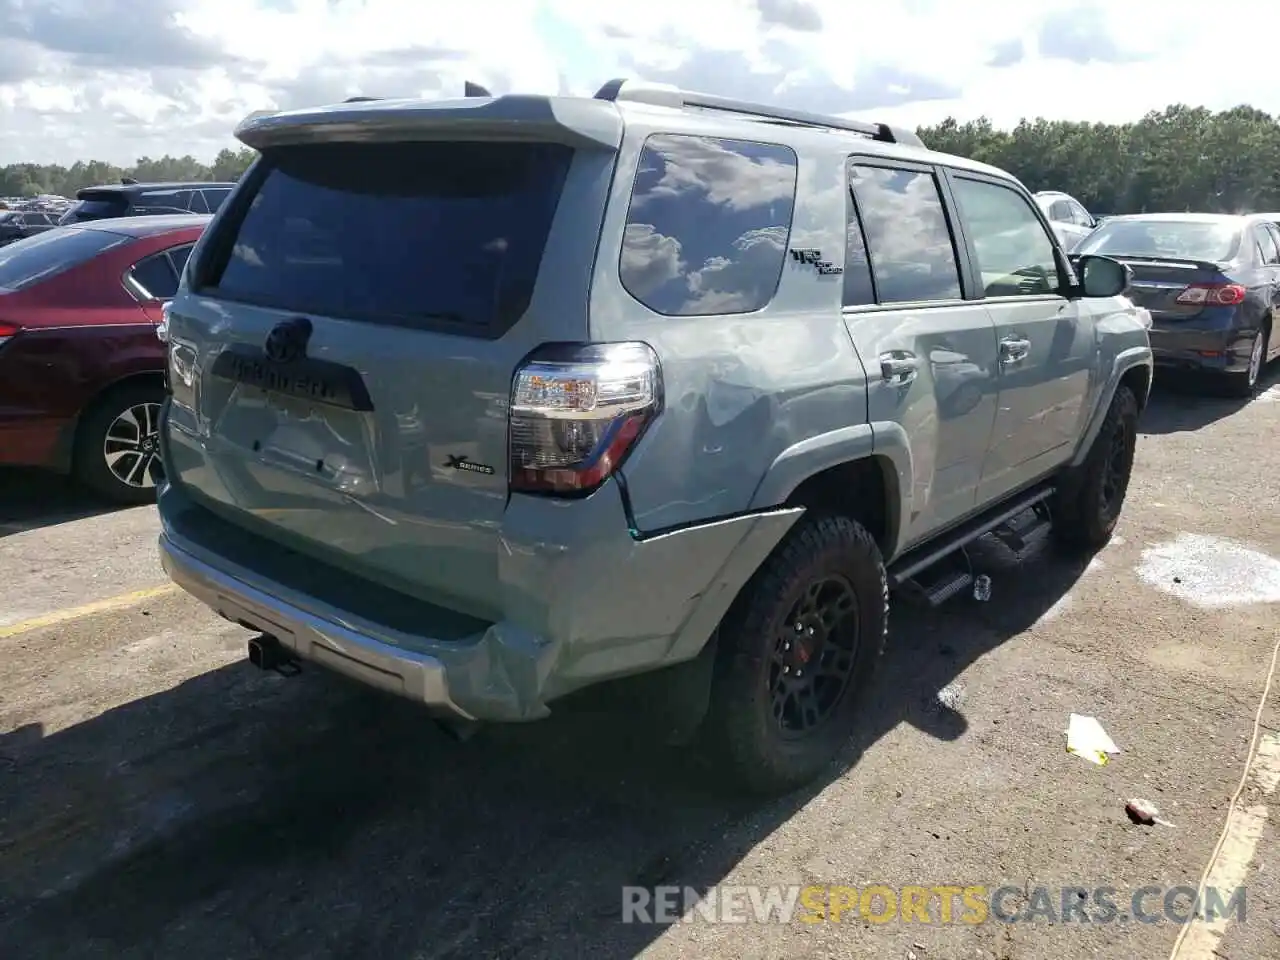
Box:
749;421;915;561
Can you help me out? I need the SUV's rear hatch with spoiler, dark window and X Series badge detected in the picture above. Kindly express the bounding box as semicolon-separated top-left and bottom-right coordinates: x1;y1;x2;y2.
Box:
166;97;621;617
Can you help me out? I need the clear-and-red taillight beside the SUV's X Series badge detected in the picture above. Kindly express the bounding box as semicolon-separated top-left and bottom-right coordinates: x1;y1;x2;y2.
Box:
509;343;662;495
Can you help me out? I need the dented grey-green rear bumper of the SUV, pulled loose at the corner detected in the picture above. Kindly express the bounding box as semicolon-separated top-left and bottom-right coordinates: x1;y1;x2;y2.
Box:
159;484;803;722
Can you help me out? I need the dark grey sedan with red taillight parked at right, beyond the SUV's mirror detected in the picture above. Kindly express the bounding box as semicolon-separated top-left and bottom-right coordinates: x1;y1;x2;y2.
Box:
1073;214;1280;396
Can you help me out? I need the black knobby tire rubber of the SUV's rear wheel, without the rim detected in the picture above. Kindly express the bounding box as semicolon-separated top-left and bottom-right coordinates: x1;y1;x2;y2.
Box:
701;515;888;795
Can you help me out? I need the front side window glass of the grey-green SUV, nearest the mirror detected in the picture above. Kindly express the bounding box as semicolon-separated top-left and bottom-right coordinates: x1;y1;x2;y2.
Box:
951;177;1059;297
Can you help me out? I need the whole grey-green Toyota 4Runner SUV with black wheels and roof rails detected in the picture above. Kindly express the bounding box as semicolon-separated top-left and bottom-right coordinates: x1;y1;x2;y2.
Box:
159;81;1152;791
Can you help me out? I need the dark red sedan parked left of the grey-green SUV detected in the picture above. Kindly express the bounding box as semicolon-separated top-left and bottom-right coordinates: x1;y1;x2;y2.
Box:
0;215;211;503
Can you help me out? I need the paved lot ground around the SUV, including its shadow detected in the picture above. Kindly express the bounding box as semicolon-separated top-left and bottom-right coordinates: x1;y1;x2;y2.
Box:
0;376;1280;960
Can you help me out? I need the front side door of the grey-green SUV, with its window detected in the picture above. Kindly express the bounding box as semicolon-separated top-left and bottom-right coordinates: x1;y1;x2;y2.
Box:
950;170;1094;502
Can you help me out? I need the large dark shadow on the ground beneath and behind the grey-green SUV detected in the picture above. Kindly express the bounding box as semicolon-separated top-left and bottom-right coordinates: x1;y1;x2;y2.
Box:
0;527;1085;960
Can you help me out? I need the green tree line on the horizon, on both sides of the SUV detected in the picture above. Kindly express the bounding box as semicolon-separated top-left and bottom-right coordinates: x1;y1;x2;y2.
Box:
0;104;1280;215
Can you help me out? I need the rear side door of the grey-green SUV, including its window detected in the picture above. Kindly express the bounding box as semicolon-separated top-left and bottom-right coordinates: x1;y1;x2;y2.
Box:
845;157;996;547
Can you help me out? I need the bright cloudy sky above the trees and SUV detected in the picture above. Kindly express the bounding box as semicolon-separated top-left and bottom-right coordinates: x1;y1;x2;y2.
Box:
0;0;1280;164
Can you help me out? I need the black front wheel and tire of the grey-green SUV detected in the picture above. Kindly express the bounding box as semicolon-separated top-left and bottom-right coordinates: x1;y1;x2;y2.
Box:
1051;384;1138;550
